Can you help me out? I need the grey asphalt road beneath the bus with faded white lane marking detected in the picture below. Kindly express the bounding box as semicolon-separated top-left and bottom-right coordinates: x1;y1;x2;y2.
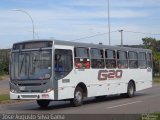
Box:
0;85;160;114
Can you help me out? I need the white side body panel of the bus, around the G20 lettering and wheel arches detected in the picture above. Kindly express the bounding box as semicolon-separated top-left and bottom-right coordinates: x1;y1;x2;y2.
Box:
55;45;152;100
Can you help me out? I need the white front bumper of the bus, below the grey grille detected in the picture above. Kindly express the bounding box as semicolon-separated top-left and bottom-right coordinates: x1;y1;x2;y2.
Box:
10;90;54;100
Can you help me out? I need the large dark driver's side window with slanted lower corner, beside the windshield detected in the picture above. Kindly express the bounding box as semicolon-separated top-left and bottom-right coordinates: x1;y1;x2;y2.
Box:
54;49;73;79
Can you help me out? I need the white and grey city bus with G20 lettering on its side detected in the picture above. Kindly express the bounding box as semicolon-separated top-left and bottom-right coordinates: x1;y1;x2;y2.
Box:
10;40;152;107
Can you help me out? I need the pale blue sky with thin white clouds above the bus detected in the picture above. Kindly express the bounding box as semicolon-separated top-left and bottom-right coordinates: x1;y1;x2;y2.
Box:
0;0;160;49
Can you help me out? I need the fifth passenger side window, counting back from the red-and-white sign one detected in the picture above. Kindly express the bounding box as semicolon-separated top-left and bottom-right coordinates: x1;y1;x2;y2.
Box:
128;52;138;68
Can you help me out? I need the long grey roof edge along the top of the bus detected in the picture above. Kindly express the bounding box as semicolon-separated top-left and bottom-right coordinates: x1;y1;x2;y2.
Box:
15;39;151;52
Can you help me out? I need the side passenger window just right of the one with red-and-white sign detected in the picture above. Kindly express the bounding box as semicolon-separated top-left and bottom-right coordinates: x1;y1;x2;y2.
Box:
90;48;105;69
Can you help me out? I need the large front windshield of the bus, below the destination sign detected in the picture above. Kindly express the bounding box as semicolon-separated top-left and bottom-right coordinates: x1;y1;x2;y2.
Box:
11;50;52;80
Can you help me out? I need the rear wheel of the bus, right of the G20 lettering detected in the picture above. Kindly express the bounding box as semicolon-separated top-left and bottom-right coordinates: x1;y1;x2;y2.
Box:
126;82;135;98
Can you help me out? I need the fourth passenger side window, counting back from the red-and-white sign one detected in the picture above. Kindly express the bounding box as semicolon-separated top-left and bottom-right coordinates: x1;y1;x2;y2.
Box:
117;51;128;69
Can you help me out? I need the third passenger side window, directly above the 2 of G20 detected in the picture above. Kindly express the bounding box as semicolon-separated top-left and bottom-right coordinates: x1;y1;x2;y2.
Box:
105;50;116;68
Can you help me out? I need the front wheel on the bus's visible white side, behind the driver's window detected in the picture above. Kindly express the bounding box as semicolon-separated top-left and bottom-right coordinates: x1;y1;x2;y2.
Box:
71;87;84;107
